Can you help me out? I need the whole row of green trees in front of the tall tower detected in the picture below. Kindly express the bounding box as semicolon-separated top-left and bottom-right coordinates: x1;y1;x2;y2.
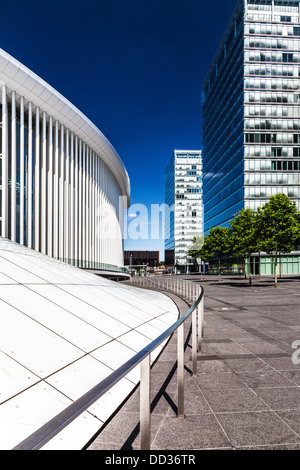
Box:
189;194;300;287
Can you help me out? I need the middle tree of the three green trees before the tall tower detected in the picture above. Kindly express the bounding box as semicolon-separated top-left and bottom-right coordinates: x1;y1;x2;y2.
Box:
230;208;260;286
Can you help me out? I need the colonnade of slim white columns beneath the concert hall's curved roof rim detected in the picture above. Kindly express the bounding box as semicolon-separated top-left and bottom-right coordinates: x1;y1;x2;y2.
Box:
0;85;124;267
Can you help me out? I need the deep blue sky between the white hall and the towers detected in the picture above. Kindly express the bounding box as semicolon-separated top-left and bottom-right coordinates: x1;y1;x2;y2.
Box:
0;0;236;258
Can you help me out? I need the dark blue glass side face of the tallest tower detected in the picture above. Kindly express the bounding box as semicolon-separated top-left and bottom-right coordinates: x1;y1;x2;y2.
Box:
202;4;244;232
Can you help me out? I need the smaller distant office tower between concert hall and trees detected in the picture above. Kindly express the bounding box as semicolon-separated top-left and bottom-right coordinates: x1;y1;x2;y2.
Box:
165;150;203;273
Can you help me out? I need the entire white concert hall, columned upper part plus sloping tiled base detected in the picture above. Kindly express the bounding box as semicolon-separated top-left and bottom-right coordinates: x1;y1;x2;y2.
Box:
0;50;178;450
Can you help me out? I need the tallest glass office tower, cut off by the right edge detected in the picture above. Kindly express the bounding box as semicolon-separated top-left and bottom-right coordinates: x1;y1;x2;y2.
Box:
202;0;300;233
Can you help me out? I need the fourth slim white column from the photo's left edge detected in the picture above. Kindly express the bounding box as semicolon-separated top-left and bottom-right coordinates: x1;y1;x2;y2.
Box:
27;103;33;248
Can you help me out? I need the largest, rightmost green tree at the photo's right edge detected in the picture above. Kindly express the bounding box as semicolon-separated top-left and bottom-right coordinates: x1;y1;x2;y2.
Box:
257;194;299;287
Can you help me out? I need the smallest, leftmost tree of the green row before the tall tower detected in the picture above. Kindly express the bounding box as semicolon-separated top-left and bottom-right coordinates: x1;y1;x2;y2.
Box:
193;227;231;282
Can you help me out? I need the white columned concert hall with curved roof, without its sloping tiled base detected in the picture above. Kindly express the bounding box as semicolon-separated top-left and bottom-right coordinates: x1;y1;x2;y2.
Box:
0;50;130;269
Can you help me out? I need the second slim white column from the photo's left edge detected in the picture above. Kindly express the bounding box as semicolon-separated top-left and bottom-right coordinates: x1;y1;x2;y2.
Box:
10;91;17;242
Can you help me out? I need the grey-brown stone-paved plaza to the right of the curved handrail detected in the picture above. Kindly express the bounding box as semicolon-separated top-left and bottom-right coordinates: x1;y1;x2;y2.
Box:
88;276;300;450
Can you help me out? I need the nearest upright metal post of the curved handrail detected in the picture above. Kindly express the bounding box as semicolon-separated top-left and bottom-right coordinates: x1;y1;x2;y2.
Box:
140;354;151;450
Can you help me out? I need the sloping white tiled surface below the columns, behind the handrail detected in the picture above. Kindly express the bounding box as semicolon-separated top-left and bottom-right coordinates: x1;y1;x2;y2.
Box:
0;238;178;450
